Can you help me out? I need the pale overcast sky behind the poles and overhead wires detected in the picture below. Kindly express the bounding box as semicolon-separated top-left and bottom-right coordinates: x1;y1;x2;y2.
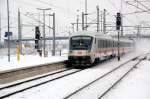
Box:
0;0;150;37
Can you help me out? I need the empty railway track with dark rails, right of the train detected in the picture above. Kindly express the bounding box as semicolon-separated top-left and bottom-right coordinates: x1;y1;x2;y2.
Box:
64;54;147;99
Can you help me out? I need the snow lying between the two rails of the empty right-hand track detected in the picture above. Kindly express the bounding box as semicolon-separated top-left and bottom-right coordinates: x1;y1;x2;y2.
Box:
69;61;137;99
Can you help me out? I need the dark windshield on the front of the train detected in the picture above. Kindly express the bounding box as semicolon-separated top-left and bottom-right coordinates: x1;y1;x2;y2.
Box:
70;36;93;50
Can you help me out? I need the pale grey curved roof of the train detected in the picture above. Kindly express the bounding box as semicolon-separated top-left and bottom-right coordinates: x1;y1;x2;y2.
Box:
70;30;133;43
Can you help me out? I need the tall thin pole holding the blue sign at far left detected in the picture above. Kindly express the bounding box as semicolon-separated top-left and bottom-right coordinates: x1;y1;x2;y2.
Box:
7;0;10;62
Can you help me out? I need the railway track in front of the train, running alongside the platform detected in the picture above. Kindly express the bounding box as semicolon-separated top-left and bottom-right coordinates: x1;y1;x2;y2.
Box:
0;68;83;99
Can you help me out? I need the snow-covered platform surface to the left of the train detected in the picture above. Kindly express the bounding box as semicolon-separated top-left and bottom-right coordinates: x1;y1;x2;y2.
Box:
0;50;67;72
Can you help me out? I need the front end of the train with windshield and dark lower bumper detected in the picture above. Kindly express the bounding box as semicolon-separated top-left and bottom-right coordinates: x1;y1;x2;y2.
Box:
68;35;93;66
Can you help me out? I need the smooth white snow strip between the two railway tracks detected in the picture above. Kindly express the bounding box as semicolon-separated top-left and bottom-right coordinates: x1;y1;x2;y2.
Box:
2;53;145;99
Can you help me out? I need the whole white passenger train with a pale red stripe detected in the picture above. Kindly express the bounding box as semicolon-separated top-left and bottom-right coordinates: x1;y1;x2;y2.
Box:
68;31;134;66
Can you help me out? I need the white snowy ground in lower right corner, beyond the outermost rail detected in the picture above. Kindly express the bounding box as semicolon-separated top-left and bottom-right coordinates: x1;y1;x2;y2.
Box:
103;60;150;99
